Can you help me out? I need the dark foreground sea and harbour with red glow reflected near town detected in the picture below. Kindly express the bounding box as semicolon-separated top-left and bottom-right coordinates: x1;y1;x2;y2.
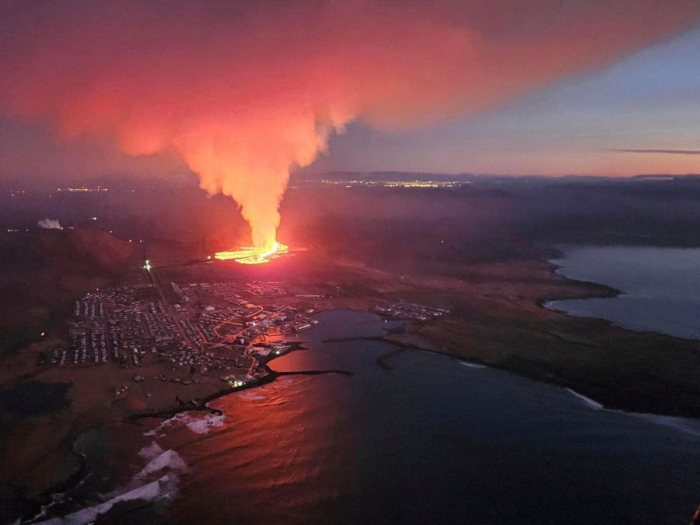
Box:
152;312;700;525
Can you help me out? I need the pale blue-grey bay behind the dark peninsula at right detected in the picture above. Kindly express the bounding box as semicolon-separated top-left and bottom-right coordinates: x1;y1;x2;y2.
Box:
546;246;700;339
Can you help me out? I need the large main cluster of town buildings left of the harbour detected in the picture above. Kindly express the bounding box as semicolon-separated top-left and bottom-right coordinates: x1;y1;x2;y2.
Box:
40;281;319;396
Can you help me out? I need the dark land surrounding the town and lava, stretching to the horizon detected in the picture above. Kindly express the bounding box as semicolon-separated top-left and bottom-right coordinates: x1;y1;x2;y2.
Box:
0;174;700;520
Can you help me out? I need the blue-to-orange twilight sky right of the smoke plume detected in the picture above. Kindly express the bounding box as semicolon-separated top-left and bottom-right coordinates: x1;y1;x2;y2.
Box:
312;25;700;176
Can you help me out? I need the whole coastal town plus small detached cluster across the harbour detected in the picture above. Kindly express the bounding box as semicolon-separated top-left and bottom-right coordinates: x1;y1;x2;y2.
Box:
32;261;448;403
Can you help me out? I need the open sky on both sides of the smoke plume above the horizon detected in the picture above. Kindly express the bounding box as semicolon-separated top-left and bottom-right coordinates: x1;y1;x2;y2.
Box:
0;0;700;182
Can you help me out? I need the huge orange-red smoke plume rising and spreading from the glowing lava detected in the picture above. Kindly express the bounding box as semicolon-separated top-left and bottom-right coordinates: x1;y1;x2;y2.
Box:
0;0;698;247
